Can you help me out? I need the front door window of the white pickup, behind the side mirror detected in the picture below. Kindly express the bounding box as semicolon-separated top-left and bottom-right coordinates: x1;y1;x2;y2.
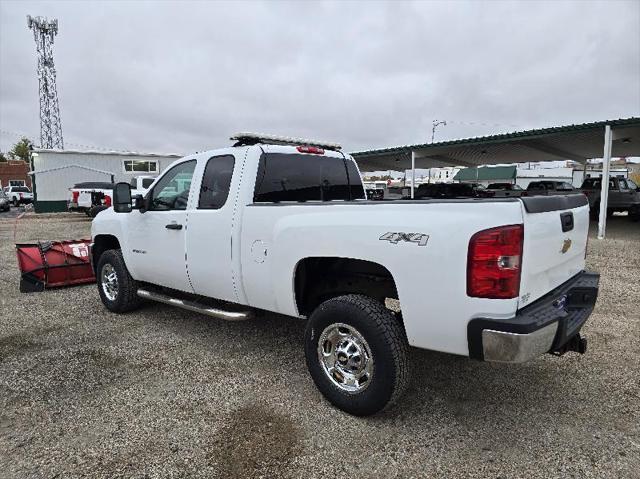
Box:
150;160;196;211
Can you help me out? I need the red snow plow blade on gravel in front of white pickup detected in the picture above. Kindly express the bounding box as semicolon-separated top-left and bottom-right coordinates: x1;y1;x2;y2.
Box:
16;239;96;293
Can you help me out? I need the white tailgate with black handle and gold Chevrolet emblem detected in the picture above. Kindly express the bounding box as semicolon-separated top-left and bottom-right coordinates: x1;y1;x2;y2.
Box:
518;194;589;308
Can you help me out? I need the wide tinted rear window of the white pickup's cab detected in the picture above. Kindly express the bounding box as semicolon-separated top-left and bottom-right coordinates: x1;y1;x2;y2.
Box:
253;153;356;202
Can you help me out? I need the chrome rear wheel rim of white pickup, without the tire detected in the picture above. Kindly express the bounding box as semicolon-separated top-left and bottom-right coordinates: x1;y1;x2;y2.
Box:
318;323;373;394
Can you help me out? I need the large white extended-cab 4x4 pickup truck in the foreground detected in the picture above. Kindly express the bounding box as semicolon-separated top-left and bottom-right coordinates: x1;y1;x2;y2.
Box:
91;134;599;415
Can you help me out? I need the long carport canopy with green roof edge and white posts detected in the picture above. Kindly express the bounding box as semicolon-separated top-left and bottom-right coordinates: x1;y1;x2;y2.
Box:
352;117;640;238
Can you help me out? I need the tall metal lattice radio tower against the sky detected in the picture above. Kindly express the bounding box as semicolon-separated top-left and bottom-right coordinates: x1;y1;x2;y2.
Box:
27;15;64;149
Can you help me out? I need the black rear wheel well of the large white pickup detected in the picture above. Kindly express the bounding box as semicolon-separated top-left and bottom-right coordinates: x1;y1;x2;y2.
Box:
294;257;398;316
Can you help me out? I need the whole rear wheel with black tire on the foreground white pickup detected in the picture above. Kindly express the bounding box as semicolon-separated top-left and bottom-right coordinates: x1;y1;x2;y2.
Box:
305;294;409;416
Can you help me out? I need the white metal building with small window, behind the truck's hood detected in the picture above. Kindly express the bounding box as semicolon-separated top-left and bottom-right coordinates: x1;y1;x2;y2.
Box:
29;149;181;213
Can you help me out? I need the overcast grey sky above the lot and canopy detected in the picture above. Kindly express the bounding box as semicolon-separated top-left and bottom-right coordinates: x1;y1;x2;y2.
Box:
0;0;640;154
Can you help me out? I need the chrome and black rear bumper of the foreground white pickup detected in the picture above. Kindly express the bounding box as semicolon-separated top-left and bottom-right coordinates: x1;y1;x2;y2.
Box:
467;271;600;363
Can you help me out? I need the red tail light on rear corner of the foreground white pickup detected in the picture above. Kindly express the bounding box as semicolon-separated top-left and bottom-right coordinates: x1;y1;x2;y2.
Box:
467;225;524;299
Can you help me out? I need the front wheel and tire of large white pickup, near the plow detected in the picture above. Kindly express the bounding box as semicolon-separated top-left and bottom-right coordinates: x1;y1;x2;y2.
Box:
96;249;142;313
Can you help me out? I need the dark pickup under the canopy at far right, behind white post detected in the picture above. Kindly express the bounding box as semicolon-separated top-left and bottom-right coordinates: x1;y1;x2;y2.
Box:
581;177;640;221
